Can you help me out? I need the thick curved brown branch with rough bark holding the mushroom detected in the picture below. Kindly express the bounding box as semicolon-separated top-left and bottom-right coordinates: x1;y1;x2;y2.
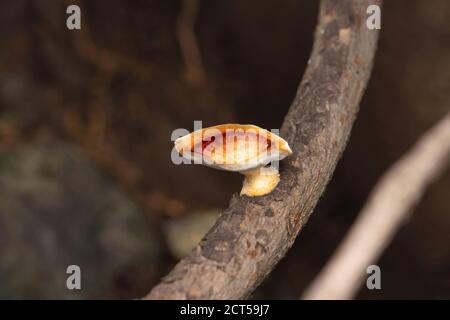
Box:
145;0;379;299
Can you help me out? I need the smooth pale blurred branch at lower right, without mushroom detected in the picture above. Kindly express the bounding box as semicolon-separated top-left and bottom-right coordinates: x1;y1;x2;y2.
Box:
304;113;450;299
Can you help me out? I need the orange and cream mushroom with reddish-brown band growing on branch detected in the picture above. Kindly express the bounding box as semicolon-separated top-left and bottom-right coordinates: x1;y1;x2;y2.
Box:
175;123;292;197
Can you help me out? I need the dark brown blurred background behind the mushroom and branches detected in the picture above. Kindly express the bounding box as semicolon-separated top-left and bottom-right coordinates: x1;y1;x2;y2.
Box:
0;0;450;299
